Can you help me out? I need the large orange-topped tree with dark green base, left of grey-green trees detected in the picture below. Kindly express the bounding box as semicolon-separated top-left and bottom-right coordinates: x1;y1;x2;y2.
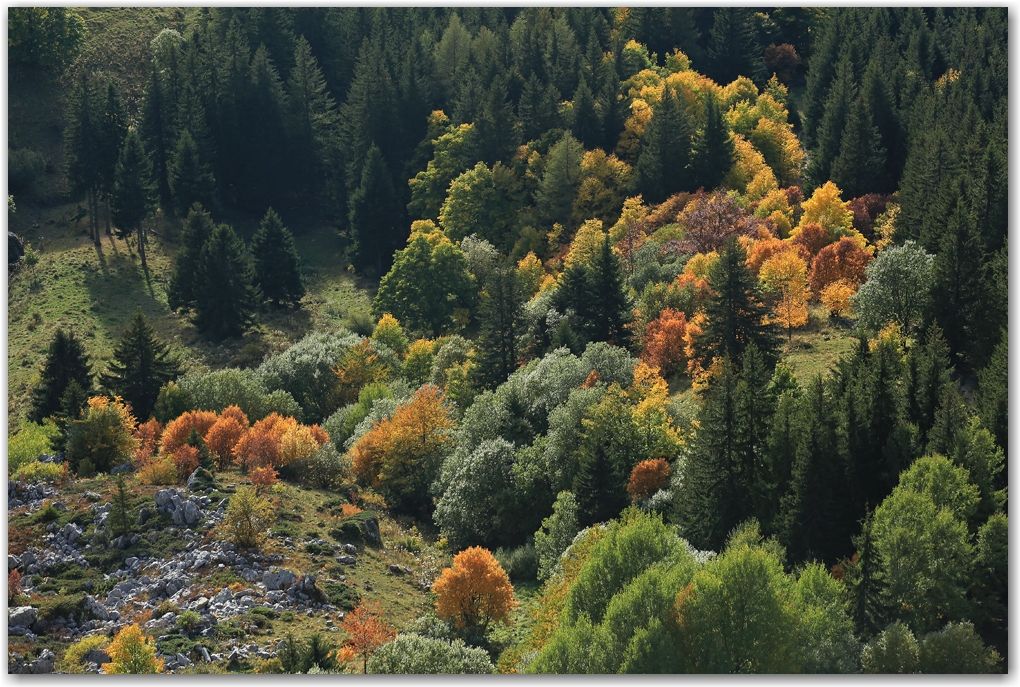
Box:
351;384;456;515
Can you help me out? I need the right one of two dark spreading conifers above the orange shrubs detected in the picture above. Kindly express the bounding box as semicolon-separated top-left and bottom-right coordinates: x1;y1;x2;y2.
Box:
99;308;181;419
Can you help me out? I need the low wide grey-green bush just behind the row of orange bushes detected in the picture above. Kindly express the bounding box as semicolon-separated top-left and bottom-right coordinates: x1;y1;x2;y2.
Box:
166;368;301;422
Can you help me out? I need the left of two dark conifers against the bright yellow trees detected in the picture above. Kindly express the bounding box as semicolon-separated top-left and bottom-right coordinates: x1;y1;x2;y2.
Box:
634;86;695;203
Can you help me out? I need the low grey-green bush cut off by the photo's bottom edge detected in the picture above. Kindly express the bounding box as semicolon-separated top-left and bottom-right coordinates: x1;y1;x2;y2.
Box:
368;634;496;675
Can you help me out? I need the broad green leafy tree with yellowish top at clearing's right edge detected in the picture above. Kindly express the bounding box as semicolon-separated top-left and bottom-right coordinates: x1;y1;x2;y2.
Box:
372;224;475;336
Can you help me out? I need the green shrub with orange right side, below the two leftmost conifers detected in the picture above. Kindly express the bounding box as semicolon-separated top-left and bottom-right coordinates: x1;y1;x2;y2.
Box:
67;397;138;472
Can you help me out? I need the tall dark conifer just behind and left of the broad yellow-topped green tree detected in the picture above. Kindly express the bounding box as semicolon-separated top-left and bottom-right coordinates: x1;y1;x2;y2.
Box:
347;144;401;274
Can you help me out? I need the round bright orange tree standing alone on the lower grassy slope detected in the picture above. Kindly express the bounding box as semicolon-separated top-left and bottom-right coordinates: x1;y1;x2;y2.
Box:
432;546;517;634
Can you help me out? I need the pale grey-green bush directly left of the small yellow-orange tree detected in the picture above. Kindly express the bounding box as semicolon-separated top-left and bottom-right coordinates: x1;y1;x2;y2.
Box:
258;328;400;422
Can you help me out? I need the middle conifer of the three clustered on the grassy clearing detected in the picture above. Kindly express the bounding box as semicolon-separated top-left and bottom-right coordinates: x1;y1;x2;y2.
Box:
194;224;259;340
